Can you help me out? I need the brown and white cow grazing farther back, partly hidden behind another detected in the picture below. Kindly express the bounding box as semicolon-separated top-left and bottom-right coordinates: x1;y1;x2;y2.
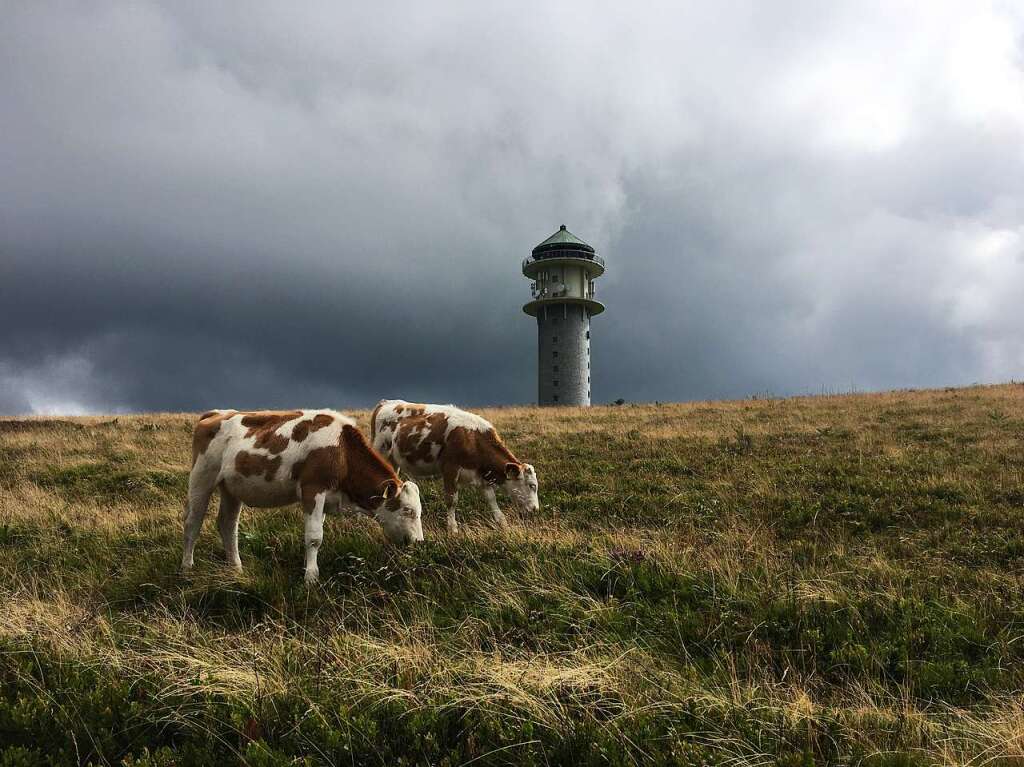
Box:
370;399;541;532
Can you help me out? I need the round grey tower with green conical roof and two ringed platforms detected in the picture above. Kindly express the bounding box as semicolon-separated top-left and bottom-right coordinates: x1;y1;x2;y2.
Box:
522;224;604;406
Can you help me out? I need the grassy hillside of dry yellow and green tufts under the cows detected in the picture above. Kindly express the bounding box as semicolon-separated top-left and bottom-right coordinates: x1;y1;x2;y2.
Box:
0;385;1024;767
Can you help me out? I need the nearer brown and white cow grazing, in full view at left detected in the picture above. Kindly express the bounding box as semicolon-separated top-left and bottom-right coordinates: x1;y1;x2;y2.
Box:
181;410;423;583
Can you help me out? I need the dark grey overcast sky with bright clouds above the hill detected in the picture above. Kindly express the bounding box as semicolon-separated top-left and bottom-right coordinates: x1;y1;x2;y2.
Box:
0;0;1024;414
